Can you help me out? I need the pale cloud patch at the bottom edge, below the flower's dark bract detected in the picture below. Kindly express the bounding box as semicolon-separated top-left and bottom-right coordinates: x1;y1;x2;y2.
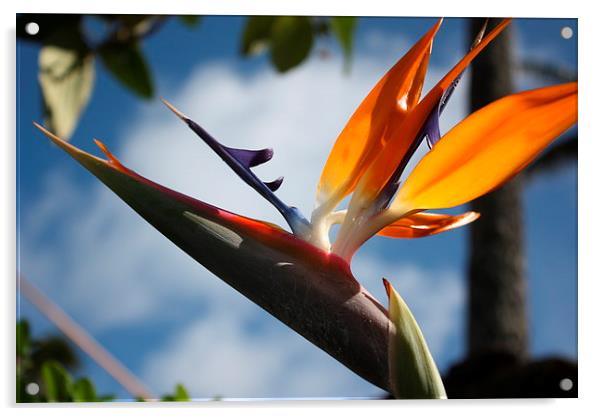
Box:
143;304;384;398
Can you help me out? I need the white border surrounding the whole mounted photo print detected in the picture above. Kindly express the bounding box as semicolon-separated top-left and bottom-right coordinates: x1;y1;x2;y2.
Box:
5;0;602;415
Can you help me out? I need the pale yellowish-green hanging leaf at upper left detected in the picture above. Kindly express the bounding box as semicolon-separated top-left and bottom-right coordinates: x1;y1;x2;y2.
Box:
38;44;94;138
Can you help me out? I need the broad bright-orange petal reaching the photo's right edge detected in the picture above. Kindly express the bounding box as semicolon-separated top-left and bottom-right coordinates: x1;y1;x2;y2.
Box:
391;82;577;213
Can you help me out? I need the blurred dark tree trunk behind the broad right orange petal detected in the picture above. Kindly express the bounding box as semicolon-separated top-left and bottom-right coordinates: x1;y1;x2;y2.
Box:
468;19;528;359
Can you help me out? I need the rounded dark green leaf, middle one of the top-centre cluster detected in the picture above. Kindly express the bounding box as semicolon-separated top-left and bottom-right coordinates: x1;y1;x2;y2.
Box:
271;16;313;72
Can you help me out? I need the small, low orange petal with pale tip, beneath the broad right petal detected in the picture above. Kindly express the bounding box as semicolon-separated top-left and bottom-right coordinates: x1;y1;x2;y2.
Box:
378;211;480;238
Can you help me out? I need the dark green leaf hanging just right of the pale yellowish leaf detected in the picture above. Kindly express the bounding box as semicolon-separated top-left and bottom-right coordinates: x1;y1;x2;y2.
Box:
100;43;153;98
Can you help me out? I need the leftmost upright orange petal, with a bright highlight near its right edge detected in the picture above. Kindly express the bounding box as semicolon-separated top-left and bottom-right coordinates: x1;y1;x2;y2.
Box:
317;20;441;205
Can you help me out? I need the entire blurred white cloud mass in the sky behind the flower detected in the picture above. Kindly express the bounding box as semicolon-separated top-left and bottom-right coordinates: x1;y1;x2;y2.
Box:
22;39;463;397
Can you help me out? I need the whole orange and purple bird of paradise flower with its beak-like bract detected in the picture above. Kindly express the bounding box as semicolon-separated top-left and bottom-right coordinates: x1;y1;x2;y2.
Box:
36;19;577;398
